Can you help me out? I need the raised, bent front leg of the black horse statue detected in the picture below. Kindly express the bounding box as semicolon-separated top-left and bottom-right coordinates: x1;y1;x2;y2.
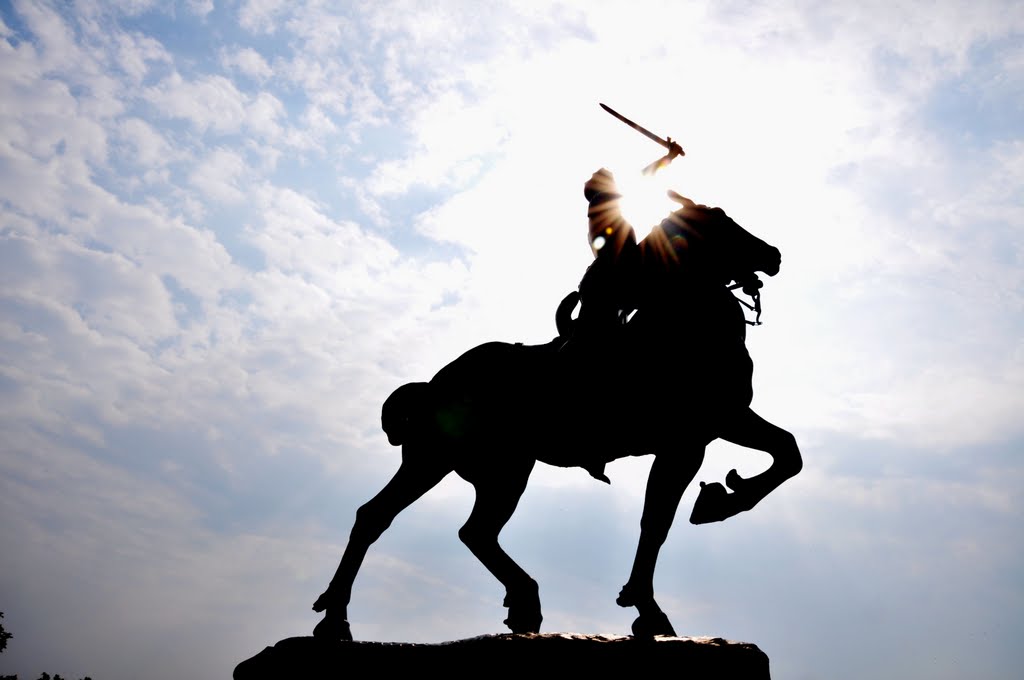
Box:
690;409;804;524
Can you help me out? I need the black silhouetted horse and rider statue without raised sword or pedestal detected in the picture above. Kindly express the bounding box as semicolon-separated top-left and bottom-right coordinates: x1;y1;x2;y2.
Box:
313;169;802;640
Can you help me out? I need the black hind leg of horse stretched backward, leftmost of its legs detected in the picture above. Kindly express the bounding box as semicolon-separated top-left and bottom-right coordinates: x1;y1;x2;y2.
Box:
313;443;453;640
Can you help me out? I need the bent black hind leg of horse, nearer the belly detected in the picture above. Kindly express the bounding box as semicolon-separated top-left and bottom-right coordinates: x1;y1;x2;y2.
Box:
457;460;544;633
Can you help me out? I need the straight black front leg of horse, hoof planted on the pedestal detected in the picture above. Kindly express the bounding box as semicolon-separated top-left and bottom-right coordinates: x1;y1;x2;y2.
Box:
615;444;705;637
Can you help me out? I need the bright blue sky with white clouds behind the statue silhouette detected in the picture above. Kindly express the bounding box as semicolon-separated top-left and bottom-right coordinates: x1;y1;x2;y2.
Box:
0;0;1024;680
